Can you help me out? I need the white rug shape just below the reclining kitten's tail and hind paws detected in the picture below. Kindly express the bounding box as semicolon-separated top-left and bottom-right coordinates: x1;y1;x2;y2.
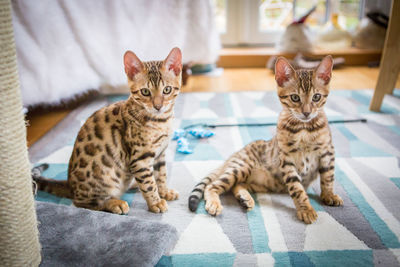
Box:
171;214;236;254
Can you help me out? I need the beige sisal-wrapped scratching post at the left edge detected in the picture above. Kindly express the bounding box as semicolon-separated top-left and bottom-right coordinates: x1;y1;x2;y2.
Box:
0;0;40;266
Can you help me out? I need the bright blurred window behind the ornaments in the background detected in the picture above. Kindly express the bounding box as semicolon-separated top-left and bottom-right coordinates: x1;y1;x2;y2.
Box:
210;0;365;45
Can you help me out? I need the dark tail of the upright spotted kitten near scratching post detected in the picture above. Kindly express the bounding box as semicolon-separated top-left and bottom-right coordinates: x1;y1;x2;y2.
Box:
31;164;72;198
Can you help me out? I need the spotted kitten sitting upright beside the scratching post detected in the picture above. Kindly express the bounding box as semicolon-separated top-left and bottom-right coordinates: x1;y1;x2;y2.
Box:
34;48;182;214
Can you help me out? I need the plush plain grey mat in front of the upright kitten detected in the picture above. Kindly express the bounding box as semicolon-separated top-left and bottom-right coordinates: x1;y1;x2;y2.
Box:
36;201;178;266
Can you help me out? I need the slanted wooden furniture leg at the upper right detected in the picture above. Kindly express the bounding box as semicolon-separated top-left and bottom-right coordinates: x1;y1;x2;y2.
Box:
369;0;400;112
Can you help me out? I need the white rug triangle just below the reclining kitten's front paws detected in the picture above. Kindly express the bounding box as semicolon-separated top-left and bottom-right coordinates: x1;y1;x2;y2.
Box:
304;211;369;251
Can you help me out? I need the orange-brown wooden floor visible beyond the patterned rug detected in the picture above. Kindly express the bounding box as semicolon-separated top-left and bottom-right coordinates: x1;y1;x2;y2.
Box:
27;67;400;145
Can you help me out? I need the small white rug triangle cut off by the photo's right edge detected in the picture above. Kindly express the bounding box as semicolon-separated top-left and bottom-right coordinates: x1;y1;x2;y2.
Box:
354;157;400;179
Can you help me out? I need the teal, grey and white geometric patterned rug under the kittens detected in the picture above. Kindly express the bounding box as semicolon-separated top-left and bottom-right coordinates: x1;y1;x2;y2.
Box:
29;90;400;266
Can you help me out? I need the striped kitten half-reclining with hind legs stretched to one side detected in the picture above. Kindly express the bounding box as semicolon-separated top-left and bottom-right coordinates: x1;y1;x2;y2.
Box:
189;56;343;223
